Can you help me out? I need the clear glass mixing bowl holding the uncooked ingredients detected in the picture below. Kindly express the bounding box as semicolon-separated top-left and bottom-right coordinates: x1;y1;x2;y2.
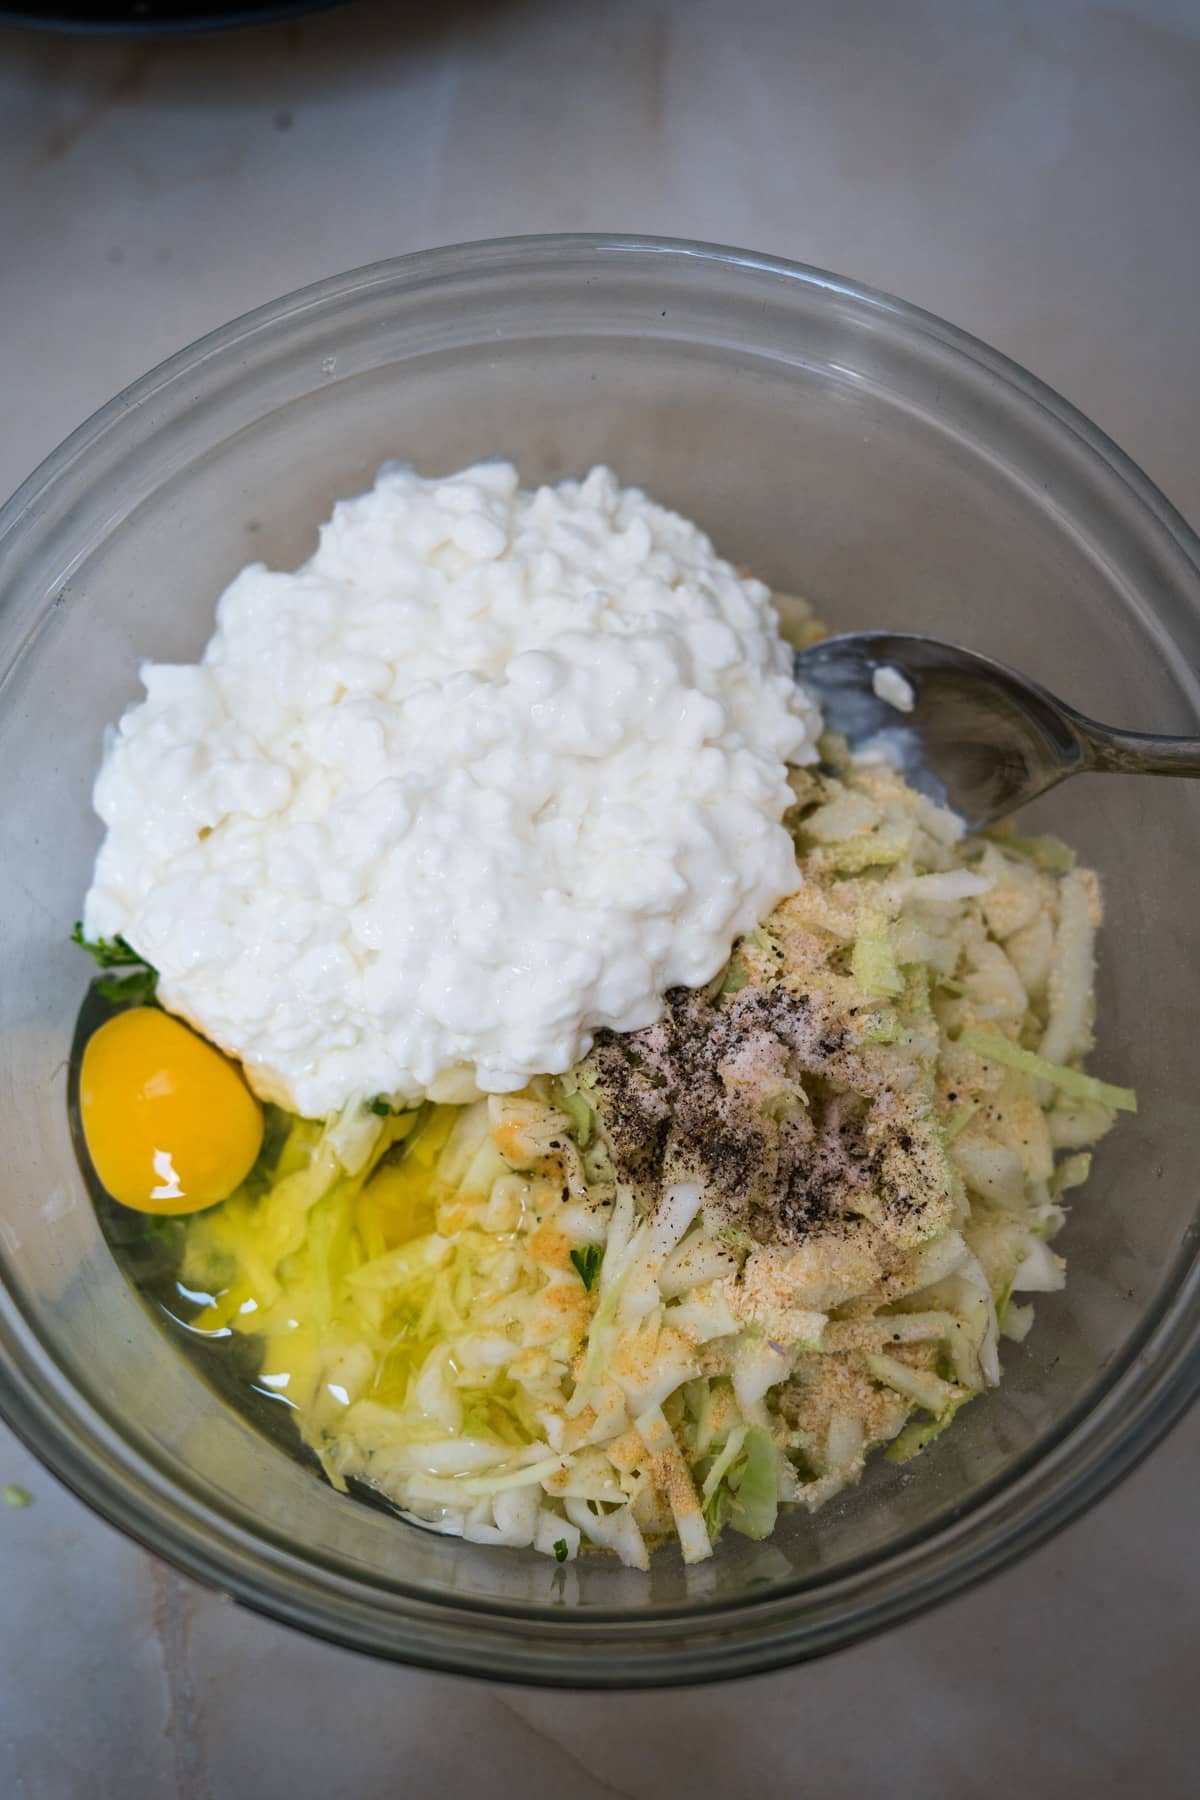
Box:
0;238;1200;1687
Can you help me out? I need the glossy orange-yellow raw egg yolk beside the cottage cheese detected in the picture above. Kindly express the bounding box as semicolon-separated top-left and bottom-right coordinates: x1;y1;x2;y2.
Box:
79;1006;263;1213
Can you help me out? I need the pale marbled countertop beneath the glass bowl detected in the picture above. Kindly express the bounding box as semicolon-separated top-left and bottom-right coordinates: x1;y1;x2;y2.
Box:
0;0;1200;1800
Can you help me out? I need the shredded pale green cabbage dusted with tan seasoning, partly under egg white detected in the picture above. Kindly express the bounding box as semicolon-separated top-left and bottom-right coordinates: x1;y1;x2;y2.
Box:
182;740;1135;1570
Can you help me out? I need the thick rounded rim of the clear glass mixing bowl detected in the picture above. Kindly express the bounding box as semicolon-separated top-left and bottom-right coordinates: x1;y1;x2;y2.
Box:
0;234;1200;1688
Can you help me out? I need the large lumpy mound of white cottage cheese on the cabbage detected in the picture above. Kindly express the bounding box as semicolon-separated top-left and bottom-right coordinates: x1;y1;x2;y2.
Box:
85;463;819;1116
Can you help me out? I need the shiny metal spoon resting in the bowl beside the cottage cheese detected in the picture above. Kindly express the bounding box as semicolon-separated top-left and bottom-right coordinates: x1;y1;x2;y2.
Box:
795;632;1200;830
